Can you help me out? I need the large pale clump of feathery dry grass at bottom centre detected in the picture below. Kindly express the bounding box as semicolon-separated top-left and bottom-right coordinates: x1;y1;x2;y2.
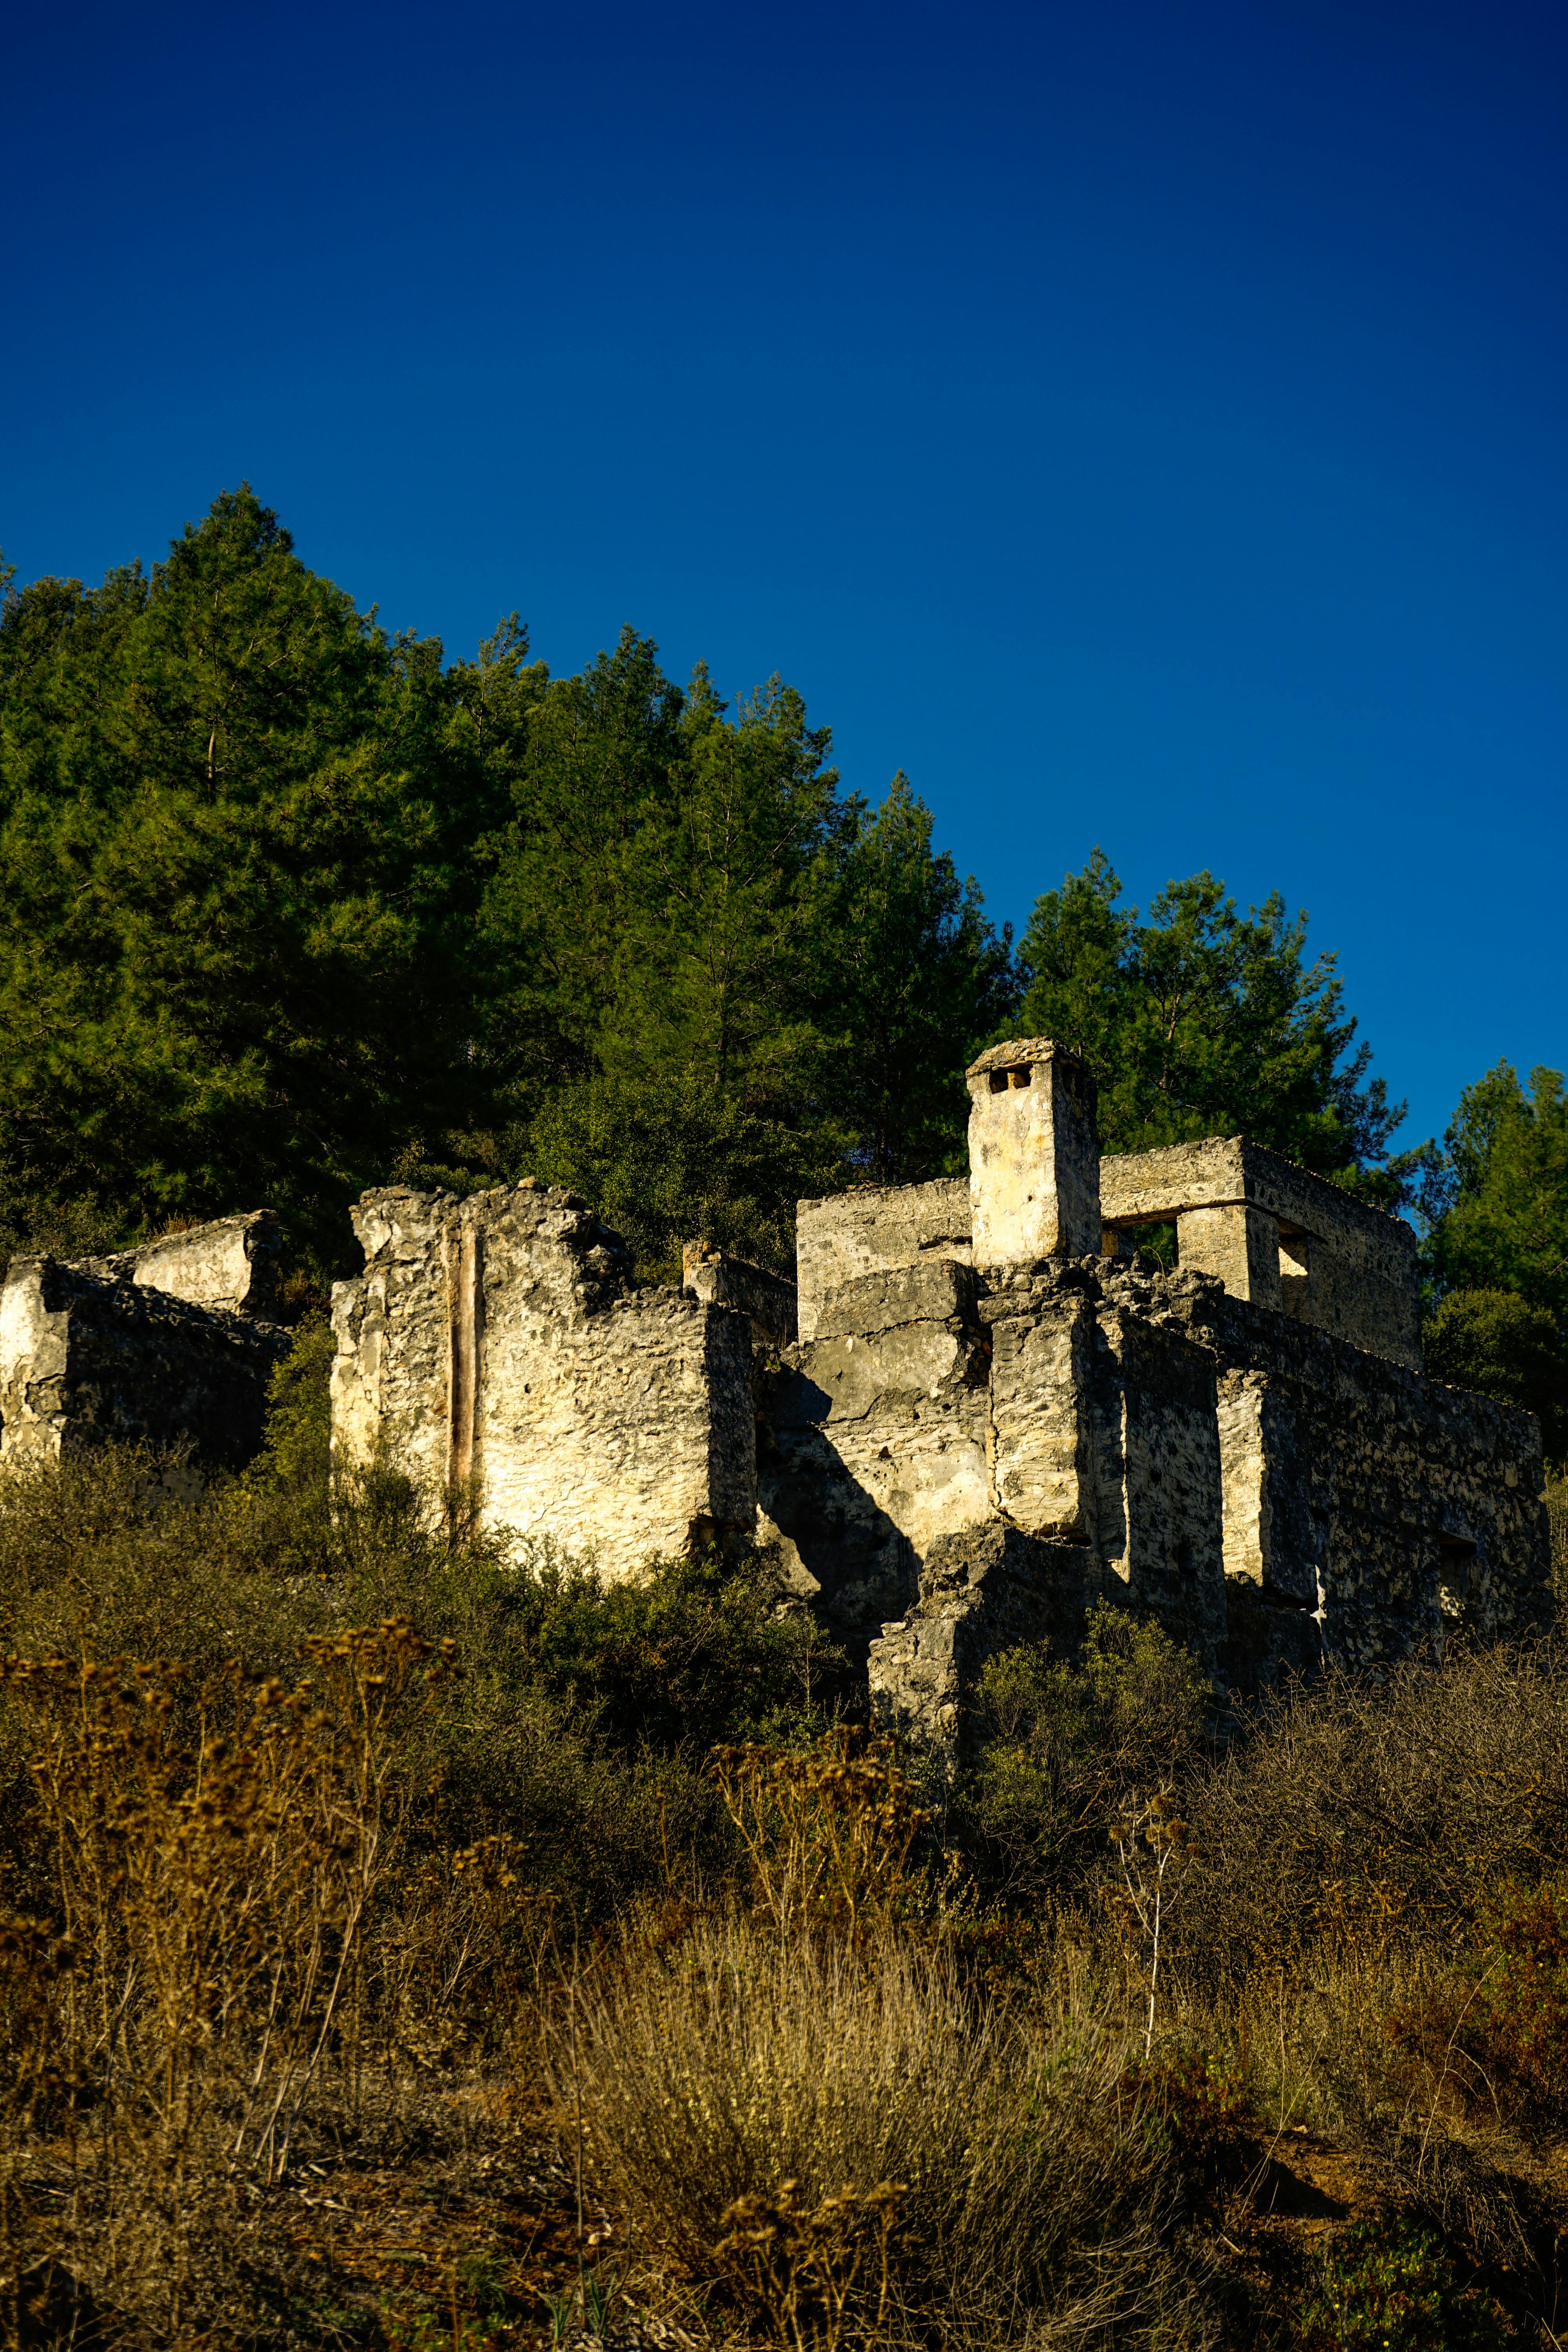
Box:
552;1912;1199;2345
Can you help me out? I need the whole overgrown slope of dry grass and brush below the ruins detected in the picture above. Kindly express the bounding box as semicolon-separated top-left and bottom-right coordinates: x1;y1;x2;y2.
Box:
0;1421;1568;2352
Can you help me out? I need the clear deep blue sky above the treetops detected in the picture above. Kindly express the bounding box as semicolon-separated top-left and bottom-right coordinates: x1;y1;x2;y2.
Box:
0;0;1568;1141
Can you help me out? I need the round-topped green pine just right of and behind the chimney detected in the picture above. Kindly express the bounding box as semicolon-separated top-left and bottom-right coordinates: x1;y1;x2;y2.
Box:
1018;849;1413;1207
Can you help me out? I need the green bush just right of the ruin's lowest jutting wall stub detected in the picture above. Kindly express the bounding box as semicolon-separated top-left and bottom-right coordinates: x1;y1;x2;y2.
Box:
957;1602;1213;1896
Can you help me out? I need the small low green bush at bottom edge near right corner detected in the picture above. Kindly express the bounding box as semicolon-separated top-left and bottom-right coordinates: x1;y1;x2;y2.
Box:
1298;2216;1509;2352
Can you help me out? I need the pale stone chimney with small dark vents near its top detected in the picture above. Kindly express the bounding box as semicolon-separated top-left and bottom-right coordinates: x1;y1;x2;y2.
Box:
966;1037;1100;1268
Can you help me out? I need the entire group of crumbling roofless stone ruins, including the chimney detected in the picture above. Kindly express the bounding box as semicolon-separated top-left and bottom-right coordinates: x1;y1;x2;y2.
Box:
0;1037;1549;1743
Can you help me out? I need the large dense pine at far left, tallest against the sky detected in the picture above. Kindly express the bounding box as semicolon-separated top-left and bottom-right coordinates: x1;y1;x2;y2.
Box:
0;489;501;1258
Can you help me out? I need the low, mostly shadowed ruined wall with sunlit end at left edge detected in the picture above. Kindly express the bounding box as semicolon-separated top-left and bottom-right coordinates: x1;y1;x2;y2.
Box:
0;1256;289;1468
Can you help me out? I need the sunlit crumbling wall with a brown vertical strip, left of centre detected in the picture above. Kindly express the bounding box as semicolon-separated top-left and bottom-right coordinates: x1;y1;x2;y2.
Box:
332;1185;755;1576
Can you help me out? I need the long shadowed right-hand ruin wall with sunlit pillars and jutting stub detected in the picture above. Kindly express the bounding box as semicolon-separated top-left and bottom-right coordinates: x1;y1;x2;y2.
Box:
863;1258;1549;1738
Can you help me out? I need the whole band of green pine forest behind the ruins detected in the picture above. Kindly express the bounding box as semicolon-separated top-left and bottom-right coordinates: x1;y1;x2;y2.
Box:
0;487;1568;1458
